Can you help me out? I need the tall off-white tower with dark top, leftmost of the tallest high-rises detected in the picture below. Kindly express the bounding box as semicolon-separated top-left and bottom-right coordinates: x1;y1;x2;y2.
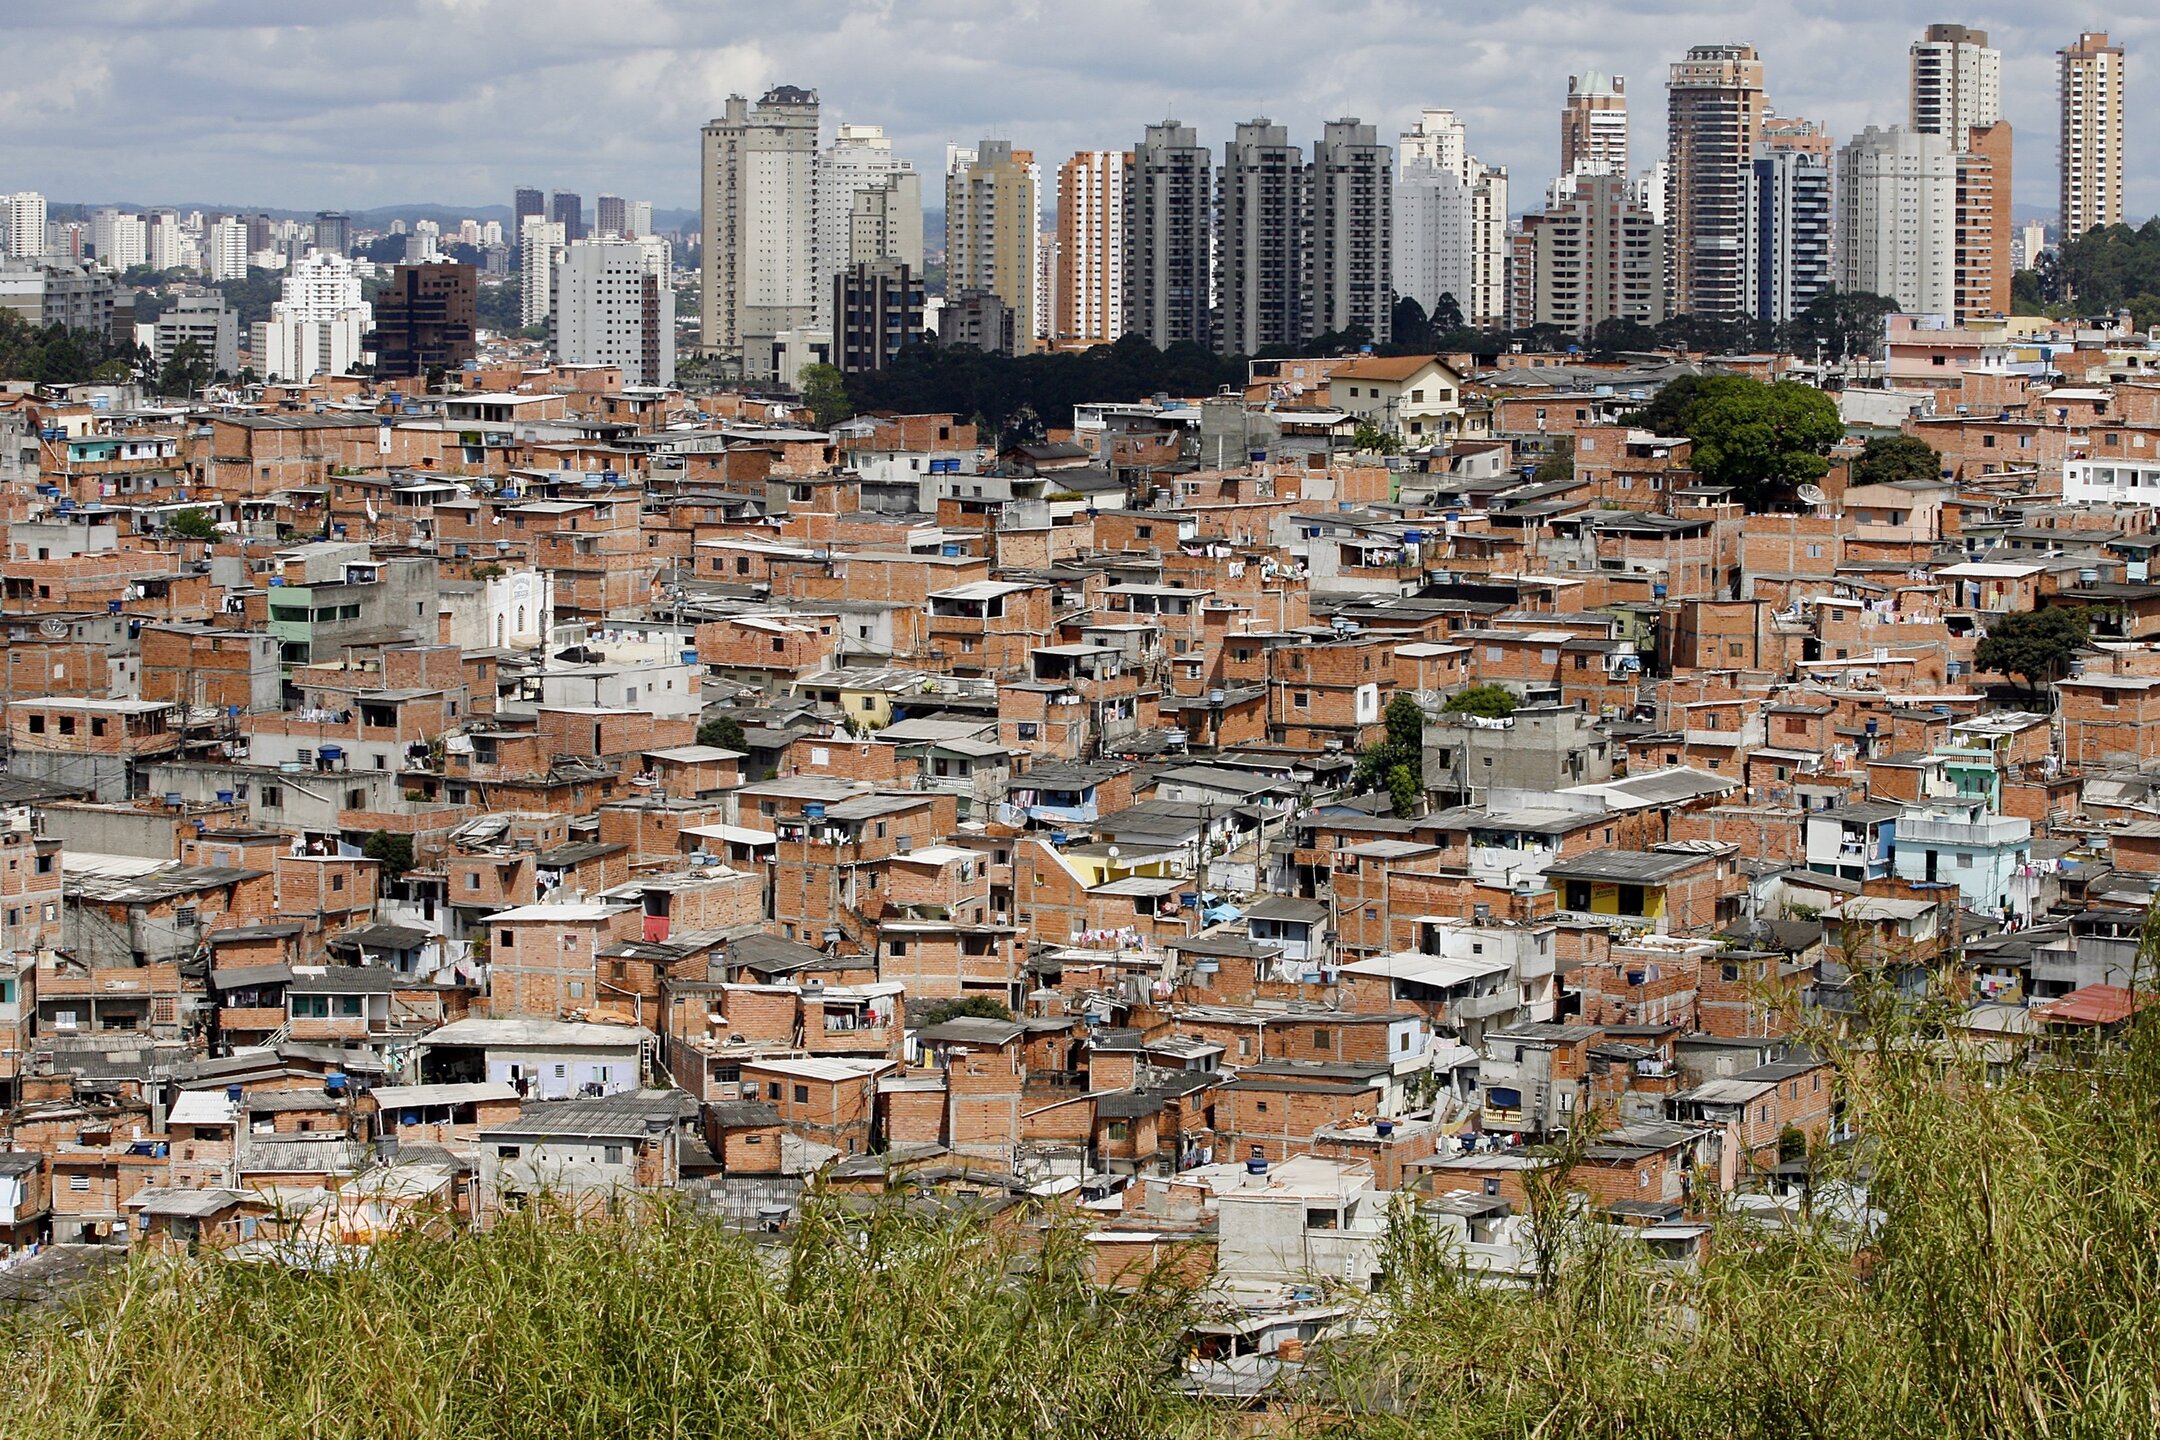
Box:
700;84;823;380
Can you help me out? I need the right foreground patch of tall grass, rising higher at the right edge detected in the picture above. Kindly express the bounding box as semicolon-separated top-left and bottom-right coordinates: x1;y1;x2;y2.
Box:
1305;980;2160;1440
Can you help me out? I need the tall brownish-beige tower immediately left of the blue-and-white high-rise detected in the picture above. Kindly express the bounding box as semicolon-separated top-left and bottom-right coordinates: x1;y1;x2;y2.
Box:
1665;45;1769;320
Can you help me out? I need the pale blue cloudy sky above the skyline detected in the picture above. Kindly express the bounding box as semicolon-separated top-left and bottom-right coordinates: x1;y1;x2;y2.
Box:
0;0;2160;214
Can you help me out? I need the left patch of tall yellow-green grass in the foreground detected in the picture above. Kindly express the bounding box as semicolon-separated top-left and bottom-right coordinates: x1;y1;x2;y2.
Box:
0;1211;1199;1440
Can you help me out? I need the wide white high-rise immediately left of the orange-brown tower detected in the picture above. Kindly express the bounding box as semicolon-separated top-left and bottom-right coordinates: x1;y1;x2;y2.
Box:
1836;125;1957;315
